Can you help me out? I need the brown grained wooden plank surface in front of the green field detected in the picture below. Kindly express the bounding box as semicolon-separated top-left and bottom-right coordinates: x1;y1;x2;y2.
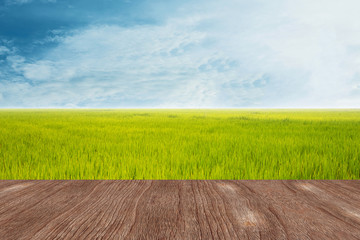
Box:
0;180;360;240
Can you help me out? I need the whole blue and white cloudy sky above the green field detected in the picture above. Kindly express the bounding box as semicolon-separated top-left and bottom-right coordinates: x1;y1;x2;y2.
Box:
0;0;360;108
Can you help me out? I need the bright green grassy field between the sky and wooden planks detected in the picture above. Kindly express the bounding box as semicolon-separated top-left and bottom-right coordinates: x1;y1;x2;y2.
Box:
0;109;360;179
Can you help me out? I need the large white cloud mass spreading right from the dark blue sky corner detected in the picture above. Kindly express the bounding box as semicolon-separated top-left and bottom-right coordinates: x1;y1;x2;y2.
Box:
0;0;360;107
